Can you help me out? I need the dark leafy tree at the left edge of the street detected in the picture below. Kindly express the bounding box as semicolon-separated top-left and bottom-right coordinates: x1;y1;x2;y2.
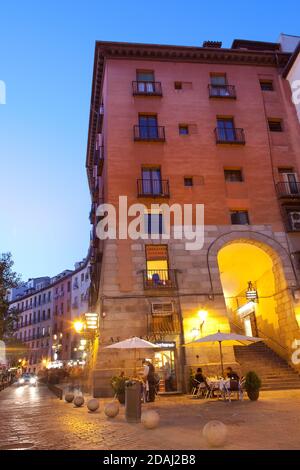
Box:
0;253;20;340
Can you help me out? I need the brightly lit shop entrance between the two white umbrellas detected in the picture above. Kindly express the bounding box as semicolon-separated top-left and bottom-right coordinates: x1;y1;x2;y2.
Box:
154;341;178;393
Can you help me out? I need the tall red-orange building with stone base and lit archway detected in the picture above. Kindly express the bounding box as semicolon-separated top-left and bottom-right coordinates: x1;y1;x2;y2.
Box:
86;40;300;396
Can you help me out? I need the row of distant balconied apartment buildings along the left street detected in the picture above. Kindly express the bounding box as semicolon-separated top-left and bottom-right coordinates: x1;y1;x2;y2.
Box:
9;258;90;372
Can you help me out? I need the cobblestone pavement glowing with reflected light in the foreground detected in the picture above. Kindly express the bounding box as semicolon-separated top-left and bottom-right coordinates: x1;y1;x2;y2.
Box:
0;386;300;450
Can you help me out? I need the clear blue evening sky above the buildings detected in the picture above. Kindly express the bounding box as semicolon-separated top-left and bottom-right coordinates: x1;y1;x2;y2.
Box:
0;0;300;279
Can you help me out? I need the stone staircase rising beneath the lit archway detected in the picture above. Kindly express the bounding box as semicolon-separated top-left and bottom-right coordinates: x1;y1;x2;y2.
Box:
234;342;300;390
